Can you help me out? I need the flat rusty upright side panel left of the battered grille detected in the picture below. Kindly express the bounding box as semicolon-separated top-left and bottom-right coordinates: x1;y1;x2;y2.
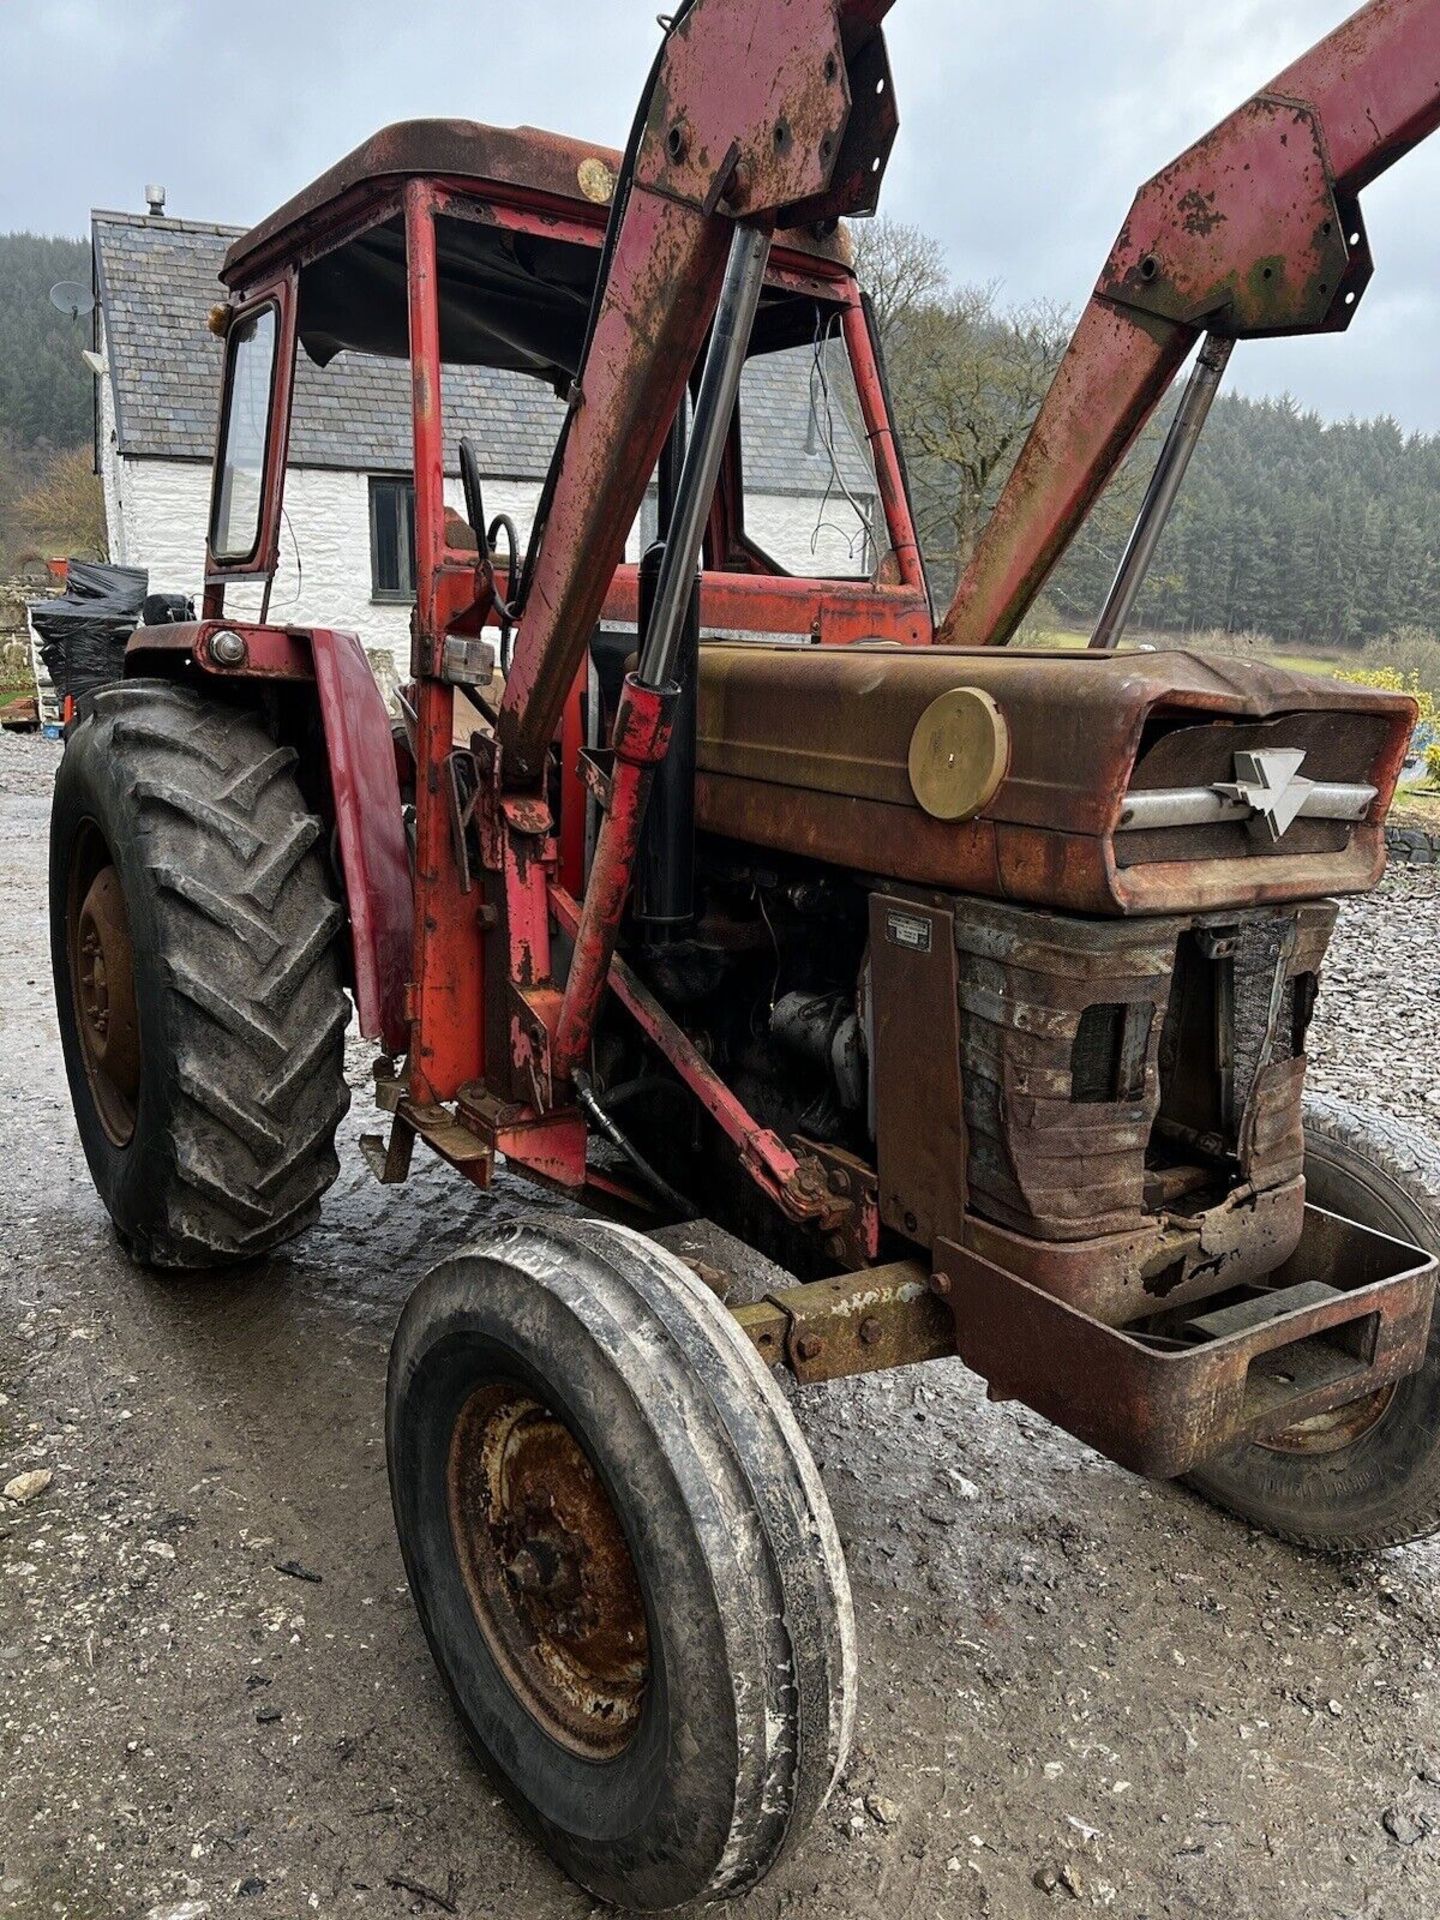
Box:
870;893;968;1246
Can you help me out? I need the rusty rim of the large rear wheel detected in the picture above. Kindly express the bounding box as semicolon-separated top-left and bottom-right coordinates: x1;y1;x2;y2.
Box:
65;828;140;1146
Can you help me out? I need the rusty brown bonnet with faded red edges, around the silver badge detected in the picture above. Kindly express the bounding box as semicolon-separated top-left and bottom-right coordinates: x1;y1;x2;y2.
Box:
697;643;1413;914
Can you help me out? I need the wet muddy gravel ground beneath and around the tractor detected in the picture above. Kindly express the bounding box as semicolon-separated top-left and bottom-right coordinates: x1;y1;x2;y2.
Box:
0;721;1440;1920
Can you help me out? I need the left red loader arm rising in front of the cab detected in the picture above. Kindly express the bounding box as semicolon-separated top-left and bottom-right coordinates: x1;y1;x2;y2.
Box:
499;0;897;780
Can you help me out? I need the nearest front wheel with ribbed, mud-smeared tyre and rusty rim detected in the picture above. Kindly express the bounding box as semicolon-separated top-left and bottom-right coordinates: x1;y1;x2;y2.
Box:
386;1221;854;1910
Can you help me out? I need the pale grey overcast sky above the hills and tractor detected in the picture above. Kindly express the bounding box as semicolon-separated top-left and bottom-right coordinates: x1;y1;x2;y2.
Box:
0;0;1440;432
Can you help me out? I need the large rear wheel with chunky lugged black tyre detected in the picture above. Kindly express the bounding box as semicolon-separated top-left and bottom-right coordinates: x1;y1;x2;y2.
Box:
50;680;349;1267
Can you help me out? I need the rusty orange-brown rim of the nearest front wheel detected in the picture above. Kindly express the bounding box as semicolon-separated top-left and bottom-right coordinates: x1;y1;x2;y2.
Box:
445;1380;649;1761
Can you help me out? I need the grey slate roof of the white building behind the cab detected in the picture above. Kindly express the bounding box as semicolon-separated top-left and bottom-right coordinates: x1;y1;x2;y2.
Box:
90;213;874;495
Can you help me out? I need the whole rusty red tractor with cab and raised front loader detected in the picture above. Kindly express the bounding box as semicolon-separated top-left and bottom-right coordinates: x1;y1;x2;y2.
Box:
52;0;1440;1908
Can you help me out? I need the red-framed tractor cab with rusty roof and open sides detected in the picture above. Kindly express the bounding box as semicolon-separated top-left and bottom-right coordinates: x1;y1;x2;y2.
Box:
205;121;931;656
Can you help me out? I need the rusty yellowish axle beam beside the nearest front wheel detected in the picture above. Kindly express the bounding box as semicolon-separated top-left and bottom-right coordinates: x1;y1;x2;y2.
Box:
732;1260;956;1386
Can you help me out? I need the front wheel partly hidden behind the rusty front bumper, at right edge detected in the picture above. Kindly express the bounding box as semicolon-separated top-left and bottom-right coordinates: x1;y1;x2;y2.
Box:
1190;1094;1440;1553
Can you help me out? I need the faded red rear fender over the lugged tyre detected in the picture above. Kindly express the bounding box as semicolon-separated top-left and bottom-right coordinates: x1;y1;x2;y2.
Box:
125;620;415;1054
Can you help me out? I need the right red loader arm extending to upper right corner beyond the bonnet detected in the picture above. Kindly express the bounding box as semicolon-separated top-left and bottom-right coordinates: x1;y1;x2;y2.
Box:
935;0;1440;647
